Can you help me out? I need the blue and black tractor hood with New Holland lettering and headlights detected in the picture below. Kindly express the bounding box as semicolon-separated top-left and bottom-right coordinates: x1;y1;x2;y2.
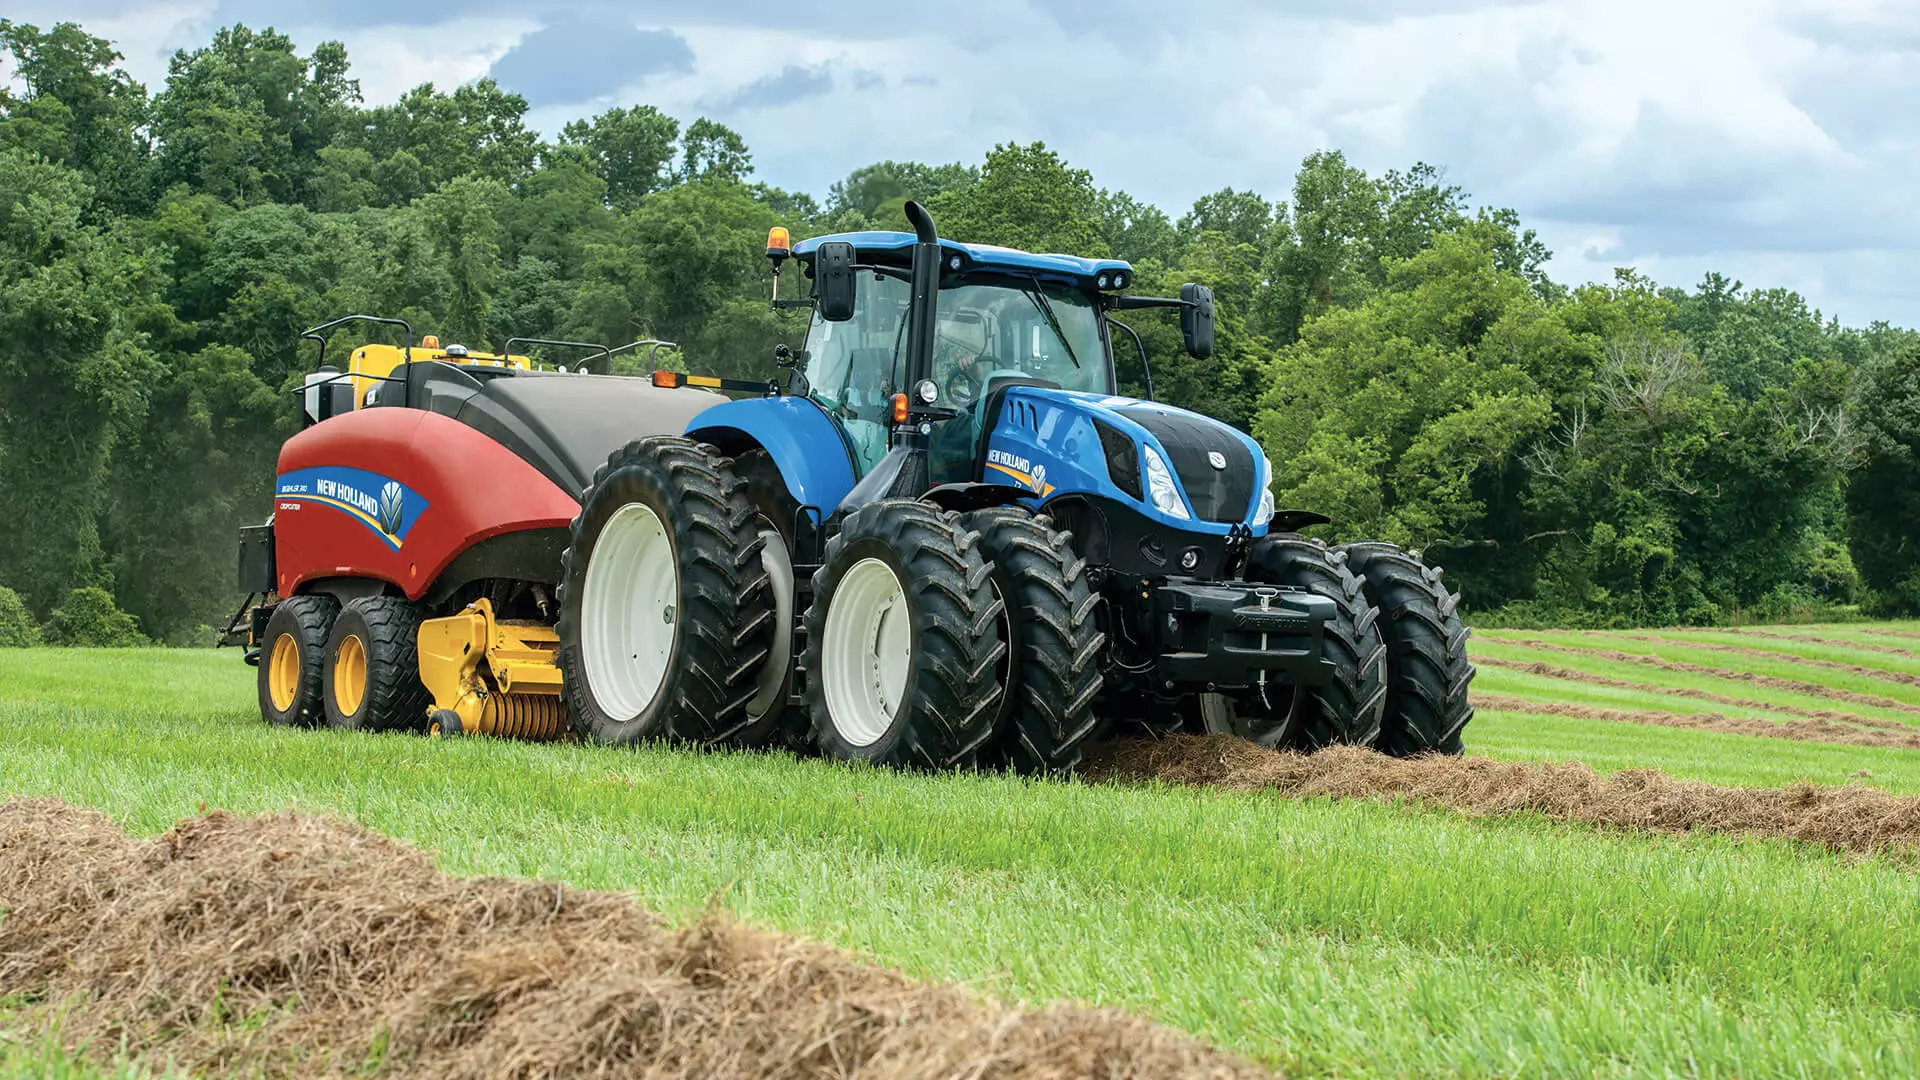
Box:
981;386;1271;534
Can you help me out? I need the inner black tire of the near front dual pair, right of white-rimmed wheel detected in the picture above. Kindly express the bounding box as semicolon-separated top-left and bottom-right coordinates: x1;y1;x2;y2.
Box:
962;507;1106;776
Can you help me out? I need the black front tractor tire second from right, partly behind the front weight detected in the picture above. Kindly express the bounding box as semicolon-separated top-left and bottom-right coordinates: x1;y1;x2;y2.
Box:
1235;534;1386;751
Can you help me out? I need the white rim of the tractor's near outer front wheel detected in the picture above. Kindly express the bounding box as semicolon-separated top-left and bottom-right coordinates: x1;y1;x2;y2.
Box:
820;559;914;746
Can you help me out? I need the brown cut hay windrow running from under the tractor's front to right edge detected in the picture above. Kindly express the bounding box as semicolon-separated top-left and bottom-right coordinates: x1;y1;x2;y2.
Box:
1096;736;1920;861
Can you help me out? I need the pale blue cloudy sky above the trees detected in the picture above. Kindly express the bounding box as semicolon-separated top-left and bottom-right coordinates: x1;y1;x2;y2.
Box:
8;0;1920;325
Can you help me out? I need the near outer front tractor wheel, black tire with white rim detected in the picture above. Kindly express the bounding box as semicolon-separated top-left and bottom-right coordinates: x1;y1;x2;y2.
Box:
804;500;1006;769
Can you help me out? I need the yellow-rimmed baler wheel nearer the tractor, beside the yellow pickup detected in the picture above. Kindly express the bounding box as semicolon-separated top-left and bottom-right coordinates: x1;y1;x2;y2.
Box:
321;596;434;732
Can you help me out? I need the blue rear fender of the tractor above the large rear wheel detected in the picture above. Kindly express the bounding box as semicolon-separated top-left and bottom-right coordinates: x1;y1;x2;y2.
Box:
687;396;858;517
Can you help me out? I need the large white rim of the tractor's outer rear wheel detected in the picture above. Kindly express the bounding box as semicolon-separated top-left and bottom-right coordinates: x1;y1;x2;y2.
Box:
580;502;680;724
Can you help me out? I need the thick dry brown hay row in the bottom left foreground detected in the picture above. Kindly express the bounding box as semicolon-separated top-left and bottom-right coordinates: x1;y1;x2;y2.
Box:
0;799;1265;1080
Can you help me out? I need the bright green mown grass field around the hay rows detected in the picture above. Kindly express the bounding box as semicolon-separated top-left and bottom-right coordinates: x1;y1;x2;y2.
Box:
0;625;1920;1076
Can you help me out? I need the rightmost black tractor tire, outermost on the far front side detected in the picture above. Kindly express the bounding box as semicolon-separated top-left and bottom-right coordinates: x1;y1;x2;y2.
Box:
1340;542;1475;757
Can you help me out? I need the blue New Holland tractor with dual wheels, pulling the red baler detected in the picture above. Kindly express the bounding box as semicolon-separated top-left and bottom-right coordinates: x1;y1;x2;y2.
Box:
557;204;1473;773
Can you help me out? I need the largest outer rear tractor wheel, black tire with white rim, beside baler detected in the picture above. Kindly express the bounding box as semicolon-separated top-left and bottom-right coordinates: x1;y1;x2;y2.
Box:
555;436;774;744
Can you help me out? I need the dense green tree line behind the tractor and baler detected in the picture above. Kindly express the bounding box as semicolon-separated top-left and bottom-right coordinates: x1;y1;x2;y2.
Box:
0;21;1920;644
